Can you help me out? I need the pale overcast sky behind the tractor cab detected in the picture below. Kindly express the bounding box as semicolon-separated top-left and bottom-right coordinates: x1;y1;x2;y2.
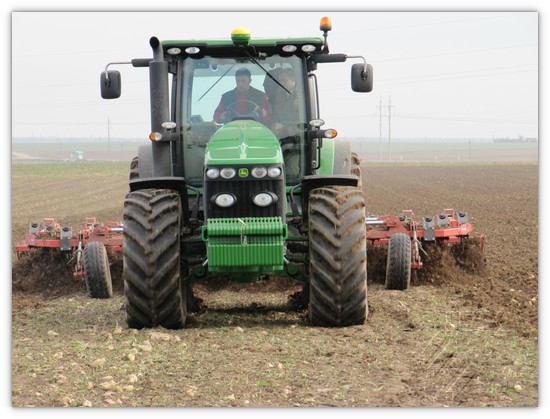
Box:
11;11;539;138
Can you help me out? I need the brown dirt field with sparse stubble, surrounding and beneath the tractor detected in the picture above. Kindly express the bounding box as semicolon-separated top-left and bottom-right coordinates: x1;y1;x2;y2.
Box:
11;164;539;407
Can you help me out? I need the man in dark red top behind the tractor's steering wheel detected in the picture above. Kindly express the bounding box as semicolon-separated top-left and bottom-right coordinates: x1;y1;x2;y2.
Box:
214;67;271;124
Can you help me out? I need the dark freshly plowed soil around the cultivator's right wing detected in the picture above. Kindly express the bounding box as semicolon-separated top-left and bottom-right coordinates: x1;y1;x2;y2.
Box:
364;165;538;337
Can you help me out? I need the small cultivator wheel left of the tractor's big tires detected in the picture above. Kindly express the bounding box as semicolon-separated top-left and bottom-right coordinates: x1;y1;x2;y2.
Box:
84;242;113;298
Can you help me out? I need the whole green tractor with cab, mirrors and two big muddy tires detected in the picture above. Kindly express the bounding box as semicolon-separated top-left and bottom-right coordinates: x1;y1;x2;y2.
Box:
100;18;373;329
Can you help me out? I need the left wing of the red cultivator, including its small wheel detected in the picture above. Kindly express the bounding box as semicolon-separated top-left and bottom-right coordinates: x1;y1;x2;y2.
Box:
15;217;123;298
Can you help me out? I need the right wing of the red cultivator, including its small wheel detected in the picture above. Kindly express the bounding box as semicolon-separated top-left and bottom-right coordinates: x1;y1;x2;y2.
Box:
366;209;485;290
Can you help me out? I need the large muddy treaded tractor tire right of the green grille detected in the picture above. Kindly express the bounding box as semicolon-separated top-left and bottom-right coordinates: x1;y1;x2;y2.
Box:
309;186;368;327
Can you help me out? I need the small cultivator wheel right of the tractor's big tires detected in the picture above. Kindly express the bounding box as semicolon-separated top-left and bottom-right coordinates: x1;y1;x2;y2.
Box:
386;233;411;291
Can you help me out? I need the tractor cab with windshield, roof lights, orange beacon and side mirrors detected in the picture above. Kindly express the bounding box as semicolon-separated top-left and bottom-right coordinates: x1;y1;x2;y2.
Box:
101;18;373;187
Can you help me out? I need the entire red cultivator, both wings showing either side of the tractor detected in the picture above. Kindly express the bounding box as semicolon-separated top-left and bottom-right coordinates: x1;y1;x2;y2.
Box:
12;209;485;298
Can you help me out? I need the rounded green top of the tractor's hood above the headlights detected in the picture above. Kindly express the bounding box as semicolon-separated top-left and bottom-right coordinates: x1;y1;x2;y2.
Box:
205;120;283;165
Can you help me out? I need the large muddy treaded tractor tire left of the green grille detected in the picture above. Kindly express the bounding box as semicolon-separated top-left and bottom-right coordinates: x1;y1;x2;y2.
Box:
122;189;188;329
